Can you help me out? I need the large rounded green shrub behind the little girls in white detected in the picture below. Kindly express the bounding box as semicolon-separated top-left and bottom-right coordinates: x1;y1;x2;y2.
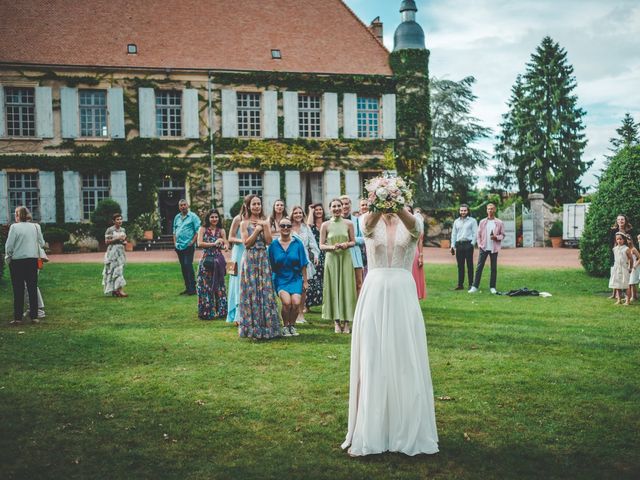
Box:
580;146;640;277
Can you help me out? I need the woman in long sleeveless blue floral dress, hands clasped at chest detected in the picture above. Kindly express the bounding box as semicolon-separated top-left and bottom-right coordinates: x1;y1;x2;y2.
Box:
235;195;281;339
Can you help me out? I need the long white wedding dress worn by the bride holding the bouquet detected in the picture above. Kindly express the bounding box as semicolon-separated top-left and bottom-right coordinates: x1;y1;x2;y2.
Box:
342;217;438;455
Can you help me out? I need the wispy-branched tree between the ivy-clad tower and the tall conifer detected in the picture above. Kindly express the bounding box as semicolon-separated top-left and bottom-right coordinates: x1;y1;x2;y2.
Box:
425;76;491;201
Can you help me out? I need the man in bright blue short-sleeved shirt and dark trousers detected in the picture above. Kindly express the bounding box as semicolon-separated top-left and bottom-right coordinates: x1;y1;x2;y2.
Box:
173;199;200;295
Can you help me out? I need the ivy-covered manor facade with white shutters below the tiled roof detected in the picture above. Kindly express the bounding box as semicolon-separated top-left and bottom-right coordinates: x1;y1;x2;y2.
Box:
0;0;429;233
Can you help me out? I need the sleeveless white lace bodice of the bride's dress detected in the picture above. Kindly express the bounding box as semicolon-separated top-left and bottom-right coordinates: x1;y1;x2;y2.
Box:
362;214;423;272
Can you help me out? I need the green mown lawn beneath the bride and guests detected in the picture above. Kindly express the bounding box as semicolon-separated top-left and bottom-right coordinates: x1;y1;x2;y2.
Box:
0;264;640;479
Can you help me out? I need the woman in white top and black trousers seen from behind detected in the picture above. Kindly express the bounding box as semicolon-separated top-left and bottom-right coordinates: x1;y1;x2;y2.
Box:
5;207;44;325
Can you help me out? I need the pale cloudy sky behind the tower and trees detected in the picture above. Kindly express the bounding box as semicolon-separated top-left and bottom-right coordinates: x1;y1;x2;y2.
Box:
345;0;640;191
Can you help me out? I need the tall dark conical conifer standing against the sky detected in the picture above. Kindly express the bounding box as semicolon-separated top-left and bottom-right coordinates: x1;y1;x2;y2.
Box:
494;37;593;203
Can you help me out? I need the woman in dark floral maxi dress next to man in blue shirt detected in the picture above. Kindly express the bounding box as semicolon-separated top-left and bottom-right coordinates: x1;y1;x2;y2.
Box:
196;210;227;320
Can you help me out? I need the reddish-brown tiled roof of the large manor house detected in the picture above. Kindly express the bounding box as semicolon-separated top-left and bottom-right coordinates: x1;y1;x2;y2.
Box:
0;0;391;75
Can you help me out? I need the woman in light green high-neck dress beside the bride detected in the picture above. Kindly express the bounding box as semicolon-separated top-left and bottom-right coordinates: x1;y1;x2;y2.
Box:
320;198;356;333
